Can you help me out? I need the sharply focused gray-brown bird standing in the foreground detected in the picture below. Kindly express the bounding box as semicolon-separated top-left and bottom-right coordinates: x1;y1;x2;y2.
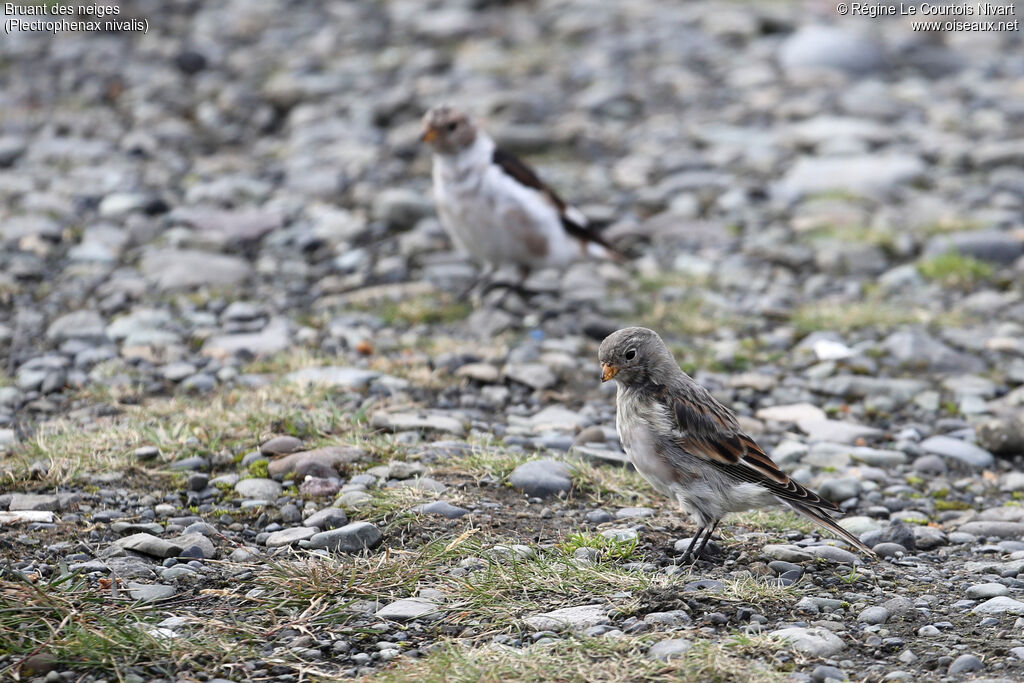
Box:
598;328;874;562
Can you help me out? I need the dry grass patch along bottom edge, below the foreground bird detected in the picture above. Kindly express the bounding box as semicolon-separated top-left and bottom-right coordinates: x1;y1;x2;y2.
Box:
362;635;786;683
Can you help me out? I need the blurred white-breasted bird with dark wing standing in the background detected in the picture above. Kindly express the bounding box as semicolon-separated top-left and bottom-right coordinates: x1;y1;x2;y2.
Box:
421;106;615;288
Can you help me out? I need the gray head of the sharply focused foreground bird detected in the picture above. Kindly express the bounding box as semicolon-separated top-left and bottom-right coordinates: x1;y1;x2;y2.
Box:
597;328;682;386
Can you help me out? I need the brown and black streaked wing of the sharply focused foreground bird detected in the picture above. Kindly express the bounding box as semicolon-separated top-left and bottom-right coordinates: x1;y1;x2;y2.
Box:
660;388;839;510
